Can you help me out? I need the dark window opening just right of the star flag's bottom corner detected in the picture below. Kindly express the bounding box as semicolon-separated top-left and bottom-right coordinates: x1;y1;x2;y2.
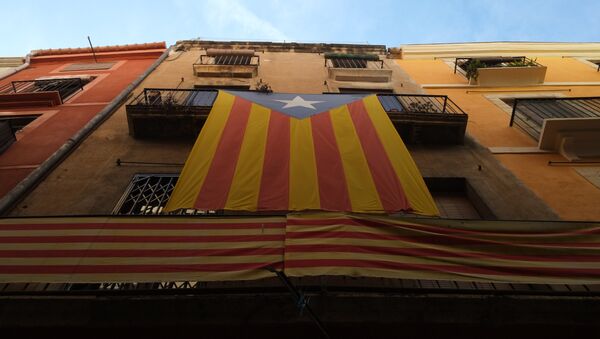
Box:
424;178;495;219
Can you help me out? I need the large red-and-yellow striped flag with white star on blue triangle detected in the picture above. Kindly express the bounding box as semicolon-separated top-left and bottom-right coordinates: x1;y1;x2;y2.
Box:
165;91;438;215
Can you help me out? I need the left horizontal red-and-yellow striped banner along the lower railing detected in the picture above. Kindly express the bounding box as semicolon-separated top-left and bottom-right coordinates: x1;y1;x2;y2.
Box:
0;217;285;282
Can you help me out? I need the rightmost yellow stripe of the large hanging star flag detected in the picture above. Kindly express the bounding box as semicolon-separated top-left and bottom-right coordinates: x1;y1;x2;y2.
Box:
363;95;440;215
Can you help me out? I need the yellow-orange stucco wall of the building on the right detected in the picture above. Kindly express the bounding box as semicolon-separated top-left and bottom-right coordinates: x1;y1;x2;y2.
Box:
397;57;600;220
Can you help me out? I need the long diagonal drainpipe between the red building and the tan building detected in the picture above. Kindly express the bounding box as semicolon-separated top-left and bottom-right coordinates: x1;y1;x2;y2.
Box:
0;46;173;215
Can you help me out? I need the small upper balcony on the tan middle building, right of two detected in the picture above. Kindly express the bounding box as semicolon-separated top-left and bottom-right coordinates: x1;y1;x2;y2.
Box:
325;53;392;83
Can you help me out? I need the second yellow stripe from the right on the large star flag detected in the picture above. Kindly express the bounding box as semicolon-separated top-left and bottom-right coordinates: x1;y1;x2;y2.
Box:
330;105;383;212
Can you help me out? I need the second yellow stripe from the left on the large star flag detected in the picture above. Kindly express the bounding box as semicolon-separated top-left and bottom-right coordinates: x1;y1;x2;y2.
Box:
225;104;271;211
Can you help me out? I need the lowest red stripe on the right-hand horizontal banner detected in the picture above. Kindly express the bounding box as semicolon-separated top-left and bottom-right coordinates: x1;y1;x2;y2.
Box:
285;259;600;278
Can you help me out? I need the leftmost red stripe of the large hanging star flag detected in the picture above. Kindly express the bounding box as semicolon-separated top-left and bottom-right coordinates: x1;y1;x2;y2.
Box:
194;97;252;210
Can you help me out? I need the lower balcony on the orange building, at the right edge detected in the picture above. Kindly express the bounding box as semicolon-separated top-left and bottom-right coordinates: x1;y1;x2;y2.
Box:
510;97;600;161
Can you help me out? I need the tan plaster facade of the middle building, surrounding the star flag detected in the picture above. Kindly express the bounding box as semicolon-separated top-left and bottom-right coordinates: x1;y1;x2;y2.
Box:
5;41;556;220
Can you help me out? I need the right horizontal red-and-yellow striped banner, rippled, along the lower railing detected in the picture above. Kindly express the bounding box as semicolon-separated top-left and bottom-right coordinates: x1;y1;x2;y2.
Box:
284;214;600;284
